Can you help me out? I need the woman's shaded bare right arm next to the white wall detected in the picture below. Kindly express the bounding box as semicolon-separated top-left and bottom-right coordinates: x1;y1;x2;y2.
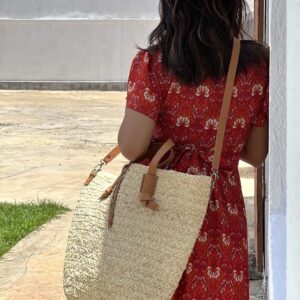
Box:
241;122;269;168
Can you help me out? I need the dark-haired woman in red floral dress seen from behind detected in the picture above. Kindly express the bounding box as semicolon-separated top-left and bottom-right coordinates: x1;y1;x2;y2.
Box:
118;0;269;300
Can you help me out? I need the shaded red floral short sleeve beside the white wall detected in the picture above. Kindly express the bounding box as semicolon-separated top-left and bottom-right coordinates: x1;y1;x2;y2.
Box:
252;61;269;127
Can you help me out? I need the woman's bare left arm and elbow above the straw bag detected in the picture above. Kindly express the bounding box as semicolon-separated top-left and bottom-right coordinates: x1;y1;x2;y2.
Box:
118;107;155;161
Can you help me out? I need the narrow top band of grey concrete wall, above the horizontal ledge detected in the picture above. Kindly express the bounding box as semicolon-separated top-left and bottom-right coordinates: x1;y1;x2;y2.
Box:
0;0;159;19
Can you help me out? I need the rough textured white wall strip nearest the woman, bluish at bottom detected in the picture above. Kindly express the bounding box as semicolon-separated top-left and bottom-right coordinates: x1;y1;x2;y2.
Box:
267;0;288;300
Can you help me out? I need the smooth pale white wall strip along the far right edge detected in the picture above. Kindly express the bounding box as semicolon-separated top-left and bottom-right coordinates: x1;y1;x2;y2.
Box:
286;0;300;300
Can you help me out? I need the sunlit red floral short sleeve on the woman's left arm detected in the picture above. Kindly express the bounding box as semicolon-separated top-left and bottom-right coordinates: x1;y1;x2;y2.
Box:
126;50;162;122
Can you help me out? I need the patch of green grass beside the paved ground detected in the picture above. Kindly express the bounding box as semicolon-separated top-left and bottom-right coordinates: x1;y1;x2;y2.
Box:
0;199;70;256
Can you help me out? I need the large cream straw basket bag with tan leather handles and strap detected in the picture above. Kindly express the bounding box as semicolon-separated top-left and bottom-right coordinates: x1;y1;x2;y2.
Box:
63;38;240;300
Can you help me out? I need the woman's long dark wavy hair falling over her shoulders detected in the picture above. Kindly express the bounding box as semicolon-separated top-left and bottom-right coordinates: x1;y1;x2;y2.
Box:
138;0;269;85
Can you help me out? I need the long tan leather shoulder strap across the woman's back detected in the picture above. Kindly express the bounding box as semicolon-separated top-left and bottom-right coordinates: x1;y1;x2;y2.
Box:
212;37;241;170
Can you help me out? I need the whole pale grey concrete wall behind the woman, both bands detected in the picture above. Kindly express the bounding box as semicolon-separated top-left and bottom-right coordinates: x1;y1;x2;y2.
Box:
0;0;253;88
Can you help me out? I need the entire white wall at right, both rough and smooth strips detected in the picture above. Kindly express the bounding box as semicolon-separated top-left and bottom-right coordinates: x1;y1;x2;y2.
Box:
268;0;300;300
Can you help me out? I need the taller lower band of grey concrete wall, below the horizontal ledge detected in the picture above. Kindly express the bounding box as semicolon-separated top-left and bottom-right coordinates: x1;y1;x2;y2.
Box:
0;19;157;81
